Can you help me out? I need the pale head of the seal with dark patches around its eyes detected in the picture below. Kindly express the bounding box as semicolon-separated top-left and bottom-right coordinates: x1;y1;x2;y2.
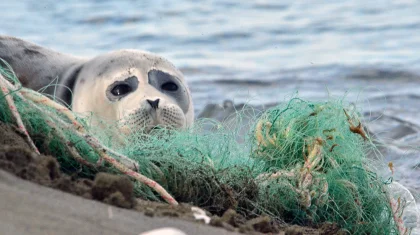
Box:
72;50;194;133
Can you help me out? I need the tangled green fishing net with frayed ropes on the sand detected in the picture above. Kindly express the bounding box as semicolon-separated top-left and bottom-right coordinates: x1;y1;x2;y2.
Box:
0;59;409;234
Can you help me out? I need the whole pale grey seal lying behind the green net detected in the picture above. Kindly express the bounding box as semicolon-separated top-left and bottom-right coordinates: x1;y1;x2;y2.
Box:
0;35;194;132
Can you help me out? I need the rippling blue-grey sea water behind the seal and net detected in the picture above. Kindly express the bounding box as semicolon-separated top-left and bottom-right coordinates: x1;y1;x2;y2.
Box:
0;0;420;207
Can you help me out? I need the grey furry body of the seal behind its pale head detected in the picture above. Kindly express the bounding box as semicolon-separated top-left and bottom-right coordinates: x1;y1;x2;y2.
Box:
0;36;85;104
